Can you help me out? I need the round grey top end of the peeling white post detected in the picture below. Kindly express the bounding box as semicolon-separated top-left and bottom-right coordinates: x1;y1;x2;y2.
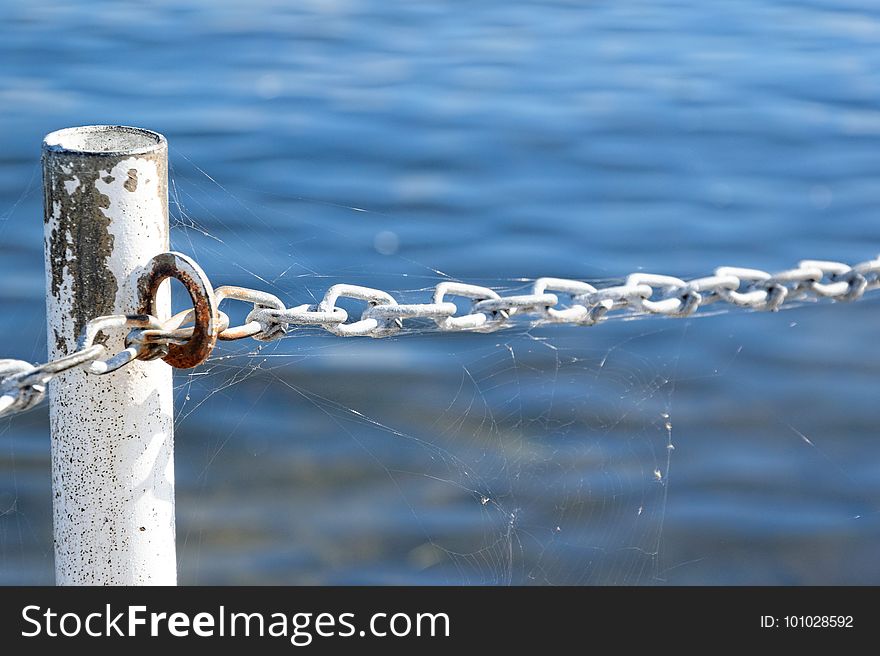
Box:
43;125;168;156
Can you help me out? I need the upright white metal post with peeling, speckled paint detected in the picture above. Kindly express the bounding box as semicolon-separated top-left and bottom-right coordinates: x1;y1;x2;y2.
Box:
43;125;177;585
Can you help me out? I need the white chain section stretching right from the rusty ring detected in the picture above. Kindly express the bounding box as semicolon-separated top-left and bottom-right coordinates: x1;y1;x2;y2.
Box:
234;258;880;340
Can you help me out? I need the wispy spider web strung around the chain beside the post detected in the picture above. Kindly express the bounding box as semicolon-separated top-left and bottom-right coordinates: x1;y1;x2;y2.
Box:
163;162;700;584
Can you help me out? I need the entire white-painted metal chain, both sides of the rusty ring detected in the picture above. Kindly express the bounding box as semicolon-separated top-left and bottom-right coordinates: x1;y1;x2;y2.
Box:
0;257;880;417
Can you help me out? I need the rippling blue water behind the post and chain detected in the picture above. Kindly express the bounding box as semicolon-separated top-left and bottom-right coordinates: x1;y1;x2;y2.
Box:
0;0;880;585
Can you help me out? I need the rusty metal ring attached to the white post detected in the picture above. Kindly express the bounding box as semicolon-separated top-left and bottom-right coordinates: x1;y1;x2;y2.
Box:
138;252;220;369
